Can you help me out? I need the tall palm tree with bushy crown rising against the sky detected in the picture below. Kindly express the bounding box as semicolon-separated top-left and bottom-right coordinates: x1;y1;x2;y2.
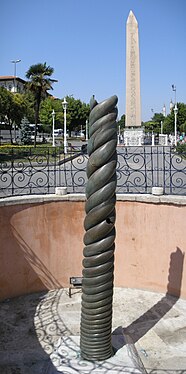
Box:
26;62;57;147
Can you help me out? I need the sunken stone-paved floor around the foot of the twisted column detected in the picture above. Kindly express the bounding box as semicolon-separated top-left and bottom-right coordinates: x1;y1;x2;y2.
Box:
0;288;186;374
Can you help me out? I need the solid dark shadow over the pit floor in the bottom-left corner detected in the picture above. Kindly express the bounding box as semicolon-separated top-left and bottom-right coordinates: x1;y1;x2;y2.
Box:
0;292;58;374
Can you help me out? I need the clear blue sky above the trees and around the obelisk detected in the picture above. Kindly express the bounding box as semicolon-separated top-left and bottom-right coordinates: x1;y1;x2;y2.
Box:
0;0;186;121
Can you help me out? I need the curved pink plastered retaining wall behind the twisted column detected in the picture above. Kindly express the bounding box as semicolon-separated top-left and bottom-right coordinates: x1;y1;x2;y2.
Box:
0;200;186;300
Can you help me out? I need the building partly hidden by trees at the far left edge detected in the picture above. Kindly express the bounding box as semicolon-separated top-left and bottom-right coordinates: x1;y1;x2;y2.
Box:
0;75;26;93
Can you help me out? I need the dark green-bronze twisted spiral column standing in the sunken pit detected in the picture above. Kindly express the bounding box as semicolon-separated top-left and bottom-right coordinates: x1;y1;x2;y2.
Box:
80;96;118;361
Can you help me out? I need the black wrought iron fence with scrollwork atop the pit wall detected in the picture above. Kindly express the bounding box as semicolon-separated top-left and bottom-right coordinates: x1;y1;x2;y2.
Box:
0;146;186;197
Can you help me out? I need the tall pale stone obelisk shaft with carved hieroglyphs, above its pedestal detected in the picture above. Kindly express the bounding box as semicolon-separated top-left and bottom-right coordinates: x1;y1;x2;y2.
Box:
125;11;141;127
